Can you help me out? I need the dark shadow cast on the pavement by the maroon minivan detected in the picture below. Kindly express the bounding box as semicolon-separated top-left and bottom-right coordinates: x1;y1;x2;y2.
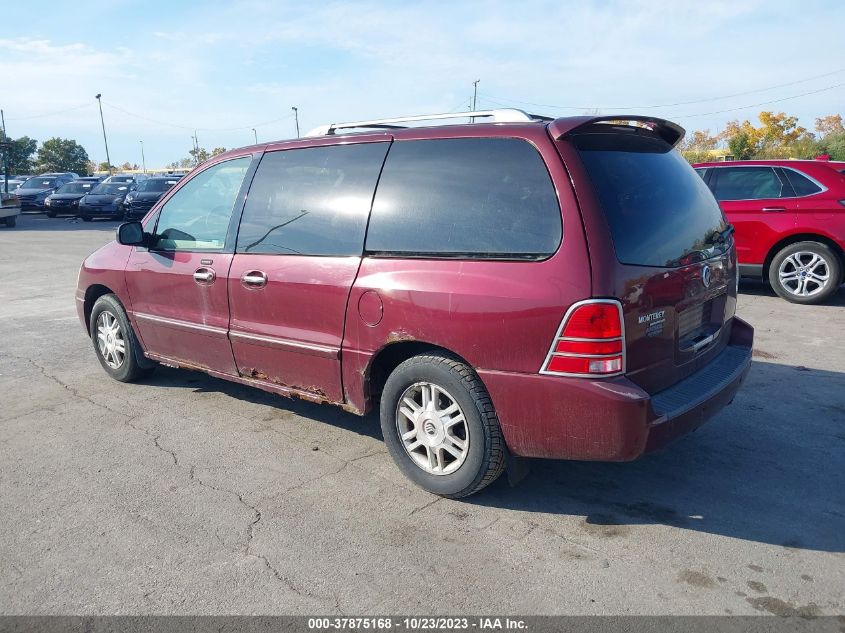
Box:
138;360;845;552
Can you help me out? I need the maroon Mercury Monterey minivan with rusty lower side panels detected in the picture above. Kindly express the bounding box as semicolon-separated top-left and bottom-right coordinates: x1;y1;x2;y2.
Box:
76;110;753;497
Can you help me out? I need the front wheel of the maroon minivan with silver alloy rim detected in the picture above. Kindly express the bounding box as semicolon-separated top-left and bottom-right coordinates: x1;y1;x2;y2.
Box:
90;294;155;382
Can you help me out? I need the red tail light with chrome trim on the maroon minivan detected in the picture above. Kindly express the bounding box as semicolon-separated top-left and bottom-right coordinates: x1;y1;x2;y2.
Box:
540;299;625;376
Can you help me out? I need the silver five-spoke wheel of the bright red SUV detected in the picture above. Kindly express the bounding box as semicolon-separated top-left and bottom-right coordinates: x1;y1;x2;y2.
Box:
769;242;842;304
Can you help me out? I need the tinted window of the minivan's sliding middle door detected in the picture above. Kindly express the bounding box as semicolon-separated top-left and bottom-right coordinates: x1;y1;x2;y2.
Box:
237;142;389;256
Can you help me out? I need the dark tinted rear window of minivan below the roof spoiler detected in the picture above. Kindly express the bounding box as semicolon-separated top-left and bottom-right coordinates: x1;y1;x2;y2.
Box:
572;133;727;267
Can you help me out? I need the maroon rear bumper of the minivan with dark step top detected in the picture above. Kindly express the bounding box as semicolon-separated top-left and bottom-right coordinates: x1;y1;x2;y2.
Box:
479;319;754;461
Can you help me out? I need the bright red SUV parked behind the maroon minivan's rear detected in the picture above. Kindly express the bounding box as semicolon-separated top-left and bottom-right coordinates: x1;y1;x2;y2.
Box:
695;160;845;303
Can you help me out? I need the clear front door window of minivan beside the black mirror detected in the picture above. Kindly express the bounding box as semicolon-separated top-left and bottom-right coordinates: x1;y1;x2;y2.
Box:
154;156;252;251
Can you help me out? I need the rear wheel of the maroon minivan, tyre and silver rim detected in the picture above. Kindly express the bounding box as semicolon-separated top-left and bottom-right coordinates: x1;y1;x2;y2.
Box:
381;353;505;499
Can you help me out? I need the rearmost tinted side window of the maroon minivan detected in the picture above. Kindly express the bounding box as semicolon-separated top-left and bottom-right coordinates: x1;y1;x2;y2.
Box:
366;138;562;259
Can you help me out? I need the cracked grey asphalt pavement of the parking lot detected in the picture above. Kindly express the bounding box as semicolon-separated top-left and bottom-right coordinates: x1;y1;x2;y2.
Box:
0;215;845;616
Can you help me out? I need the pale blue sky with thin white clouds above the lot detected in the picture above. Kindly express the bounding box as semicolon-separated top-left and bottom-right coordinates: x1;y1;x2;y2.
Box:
0;0;845;167
